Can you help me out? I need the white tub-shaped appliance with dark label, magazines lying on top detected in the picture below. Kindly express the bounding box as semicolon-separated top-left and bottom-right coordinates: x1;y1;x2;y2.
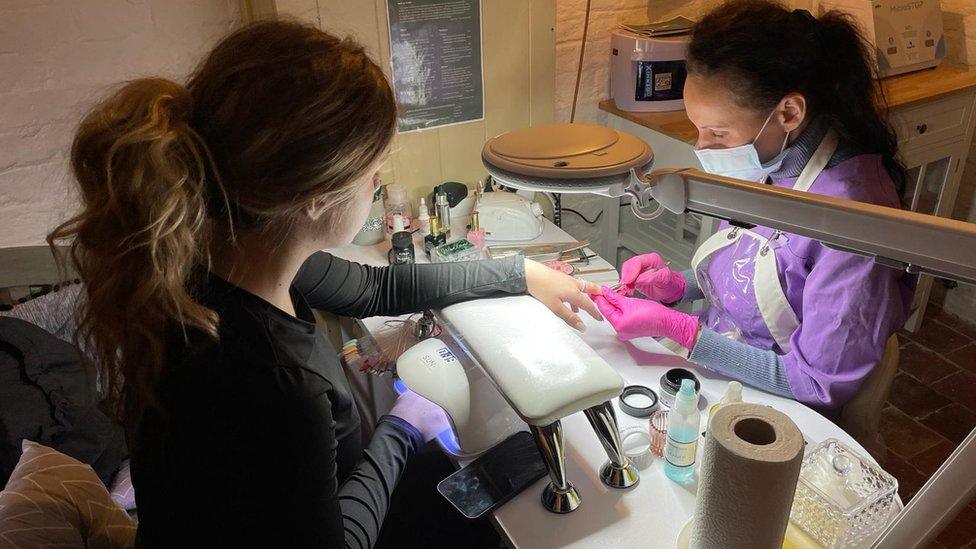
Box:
610;29;690;112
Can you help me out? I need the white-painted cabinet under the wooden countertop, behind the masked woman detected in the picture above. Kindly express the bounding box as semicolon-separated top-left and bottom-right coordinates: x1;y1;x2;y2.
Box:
591;88;976;331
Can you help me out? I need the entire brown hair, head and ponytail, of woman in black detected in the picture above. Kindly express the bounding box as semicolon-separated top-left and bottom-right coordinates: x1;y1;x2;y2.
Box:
48;21;396;432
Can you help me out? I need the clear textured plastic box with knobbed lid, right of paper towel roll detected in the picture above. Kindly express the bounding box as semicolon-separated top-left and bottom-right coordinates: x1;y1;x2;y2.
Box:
790;438;898;549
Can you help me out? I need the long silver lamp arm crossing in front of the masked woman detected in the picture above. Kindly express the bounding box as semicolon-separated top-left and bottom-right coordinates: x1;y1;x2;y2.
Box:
624;169;976;284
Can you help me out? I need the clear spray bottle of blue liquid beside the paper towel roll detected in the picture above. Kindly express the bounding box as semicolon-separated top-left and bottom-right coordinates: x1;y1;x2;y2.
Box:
664;379;701;484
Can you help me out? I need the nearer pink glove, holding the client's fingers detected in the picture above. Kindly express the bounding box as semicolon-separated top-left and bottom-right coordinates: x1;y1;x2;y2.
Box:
592;287;699;349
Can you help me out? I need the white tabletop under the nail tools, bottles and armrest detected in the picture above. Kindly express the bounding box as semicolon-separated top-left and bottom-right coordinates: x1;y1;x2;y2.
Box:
330;216;884;549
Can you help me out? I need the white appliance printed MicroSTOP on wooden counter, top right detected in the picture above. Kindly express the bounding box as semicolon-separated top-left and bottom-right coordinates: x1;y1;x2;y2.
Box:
820;0;946;77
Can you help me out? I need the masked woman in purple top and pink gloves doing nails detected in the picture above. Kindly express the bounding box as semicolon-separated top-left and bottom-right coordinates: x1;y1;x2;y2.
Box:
594;0;914;411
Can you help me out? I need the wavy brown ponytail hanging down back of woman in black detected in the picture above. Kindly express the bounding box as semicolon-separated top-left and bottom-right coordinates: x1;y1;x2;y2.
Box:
48;78;217;426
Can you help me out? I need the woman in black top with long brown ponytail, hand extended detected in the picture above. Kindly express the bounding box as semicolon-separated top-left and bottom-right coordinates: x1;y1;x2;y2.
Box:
49;22;599;547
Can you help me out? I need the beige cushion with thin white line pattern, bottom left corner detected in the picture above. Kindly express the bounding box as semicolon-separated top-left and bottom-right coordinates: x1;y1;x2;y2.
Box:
0;440;136;549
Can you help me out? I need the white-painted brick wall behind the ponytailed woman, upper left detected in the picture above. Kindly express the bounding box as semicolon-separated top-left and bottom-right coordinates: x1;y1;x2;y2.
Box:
0;0;240;247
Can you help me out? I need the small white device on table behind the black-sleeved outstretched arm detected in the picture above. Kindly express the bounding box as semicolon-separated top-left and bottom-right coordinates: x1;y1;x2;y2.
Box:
475;191;543;242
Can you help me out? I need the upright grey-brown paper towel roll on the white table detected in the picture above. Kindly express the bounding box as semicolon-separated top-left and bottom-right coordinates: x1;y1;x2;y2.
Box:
691;403;803;549
